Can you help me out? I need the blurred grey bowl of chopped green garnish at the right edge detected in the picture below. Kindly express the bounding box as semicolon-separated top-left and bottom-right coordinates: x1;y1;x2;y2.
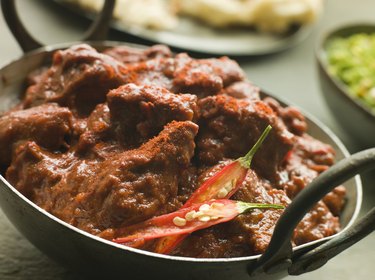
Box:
316;22;375;147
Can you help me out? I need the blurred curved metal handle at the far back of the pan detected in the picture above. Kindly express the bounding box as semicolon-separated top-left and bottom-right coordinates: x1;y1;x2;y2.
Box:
1;0;116;52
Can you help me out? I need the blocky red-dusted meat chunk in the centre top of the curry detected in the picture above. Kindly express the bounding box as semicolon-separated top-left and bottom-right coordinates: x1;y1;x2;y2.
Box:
78;84;197;154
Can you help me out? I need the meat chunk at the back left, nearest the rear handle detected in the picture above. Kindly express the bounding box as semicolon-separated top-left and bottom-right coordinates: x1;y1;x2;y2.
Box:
23;44;129;116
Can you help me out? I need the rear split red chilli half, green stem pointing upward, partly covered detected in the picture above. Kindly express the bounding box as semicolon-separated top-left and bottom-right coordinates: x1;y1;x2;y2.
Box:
155;125;272;254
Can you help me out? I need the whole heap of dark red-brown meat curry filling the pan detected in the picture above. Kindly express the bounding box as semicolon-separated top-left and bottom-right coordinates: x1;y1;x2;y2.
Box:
0;44;345;258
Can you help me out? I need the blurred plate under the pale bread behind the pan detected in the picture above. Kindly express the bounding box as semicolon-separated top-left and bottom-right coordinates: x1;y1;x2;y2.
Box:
54;0;312;56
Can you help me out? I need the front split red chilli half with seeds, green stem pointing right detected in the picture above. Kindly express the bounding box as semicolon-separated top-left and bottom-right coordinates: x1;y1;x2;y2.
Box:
113;199;284;246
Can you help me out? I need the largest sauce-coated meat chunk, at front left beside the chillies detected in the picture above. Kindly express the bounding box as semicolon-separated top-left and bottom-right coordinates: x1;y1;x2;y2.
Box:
7;122;198;234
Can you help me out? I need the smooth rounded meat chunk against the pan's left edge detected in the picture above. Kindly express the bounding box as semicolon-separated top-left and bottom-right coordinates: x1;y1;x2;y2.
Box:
0;103;72;166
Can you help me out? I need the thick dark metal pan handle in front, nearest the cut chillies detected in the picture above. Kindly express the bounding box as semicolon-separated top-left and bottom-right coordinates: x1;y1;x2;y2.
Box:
248;148;375;276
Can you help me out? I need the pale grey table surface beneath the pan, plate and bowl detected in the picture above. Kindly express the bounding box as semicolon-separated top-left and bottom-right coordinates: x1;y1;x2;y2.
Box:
0;0;375;280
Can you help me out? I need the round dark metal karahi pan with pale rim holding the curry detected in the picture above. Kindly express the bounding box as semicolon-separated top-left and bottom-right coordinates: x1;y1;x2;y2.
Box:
0;0;375;280
